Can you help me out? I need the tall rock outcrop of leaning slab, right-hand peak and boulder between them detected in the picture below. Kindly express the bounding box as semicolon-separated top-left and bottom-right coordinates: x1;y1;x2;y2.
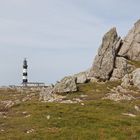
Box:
89;20;140;81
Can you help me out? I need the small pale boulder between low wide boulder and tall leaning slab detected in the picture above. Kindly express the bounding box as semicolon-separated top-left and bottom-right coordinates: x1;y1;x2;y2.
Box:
74;72;88;84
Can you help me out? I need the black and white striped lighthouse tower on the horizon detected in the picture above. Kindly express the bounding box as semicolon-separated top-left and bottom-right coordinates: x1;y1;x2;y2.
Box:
22;58;28;86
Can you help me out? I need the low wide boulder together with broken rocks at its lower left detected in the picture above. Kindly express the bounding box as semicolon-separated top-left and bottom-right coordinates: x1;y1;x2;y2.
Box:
39;76;77;103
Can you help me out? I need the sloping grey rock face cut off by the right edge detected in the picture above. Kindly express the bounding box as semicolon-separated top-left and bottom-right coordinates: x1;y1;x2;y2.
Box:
119;20;140;61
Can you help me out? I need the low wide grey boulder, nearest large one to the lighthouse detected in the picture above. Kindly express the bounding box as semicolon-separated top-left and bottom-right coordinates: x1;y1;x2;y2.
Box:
53;76;77;93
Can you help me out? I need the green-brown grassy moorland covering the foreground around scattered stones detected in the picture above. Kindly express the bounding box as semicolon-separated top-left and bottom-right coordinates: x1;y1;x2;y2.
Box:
0;82;140;140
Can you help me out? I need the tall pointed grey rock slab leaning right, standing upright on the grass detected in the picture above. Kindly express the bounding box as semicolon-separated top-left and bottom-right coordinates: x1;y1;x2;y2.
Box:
89;28;121;80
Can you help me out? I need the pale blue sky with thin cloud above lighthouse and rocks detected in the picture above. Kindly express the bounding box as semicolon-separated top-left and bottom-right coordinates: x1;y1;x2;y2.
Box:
0;0;140;86
